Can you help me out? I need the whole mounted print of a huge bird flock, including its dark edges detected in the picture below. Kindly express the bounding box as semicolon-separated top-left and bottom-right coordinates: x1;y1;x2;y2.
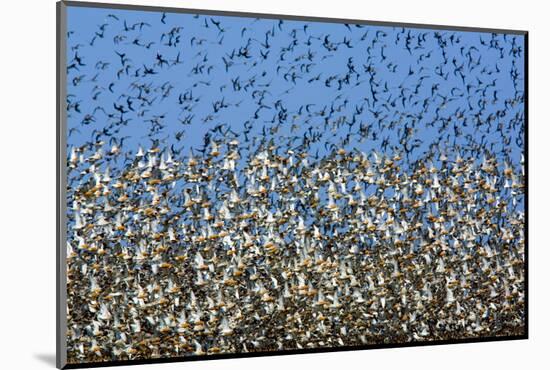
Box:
57;1;527;368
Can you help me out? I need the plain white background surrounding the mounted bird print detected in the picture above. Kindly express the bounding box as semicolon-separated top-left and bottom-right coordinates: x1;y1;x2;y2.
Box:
0;0;550;370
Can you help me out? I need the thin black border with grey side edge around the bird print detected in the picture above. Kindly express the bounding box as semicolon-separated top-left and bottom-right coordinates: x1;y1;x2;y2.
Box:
56;0;529;369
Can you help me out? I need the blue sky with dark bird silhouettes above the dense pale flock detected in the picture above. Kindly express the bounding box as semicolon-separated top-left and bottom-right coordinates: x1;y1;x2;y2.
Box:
67;7;524;175
